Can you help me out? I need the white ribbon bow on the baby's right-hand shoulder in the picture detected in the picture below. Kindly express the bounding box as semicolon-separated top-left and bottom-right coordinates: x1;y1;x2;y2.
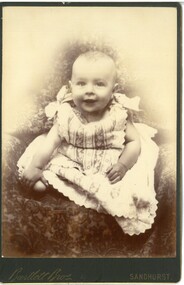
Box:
113;93;140;111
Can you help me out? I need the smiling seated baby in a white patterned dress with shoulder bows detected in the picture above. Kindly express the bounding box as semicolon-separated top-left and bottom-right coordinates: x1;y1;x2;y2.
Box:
18;51;158;235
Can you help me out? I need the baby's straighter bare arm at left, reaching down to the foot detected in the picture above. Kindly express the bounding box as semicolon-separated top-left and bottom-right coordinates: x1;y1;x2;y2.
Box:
21;125;61;188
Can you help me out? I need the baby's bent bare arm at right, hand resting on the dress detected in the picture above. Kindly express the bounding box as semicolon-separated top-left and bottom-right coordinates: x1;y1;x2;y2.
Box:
107;120;141;184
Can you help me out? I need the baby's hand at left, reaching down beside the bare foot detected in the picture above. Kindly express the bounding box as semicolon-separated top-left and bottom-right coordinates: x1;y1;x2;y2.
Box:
20;165;48;188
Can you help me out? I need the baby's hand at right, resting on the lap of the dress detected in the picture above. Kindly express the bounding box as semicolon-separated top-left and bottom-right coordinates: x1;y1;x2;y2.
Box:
106;161;127;184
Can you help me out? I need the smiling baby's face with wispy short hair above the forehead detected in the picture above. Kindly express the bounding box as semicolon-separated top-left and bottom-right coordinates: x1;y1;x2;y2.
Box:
71;58;116;114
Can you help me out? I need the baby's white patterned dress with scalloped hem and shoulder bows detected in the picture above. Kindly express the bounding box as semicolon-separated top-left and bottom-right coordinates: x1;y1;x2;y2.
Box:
17;93;158;235
